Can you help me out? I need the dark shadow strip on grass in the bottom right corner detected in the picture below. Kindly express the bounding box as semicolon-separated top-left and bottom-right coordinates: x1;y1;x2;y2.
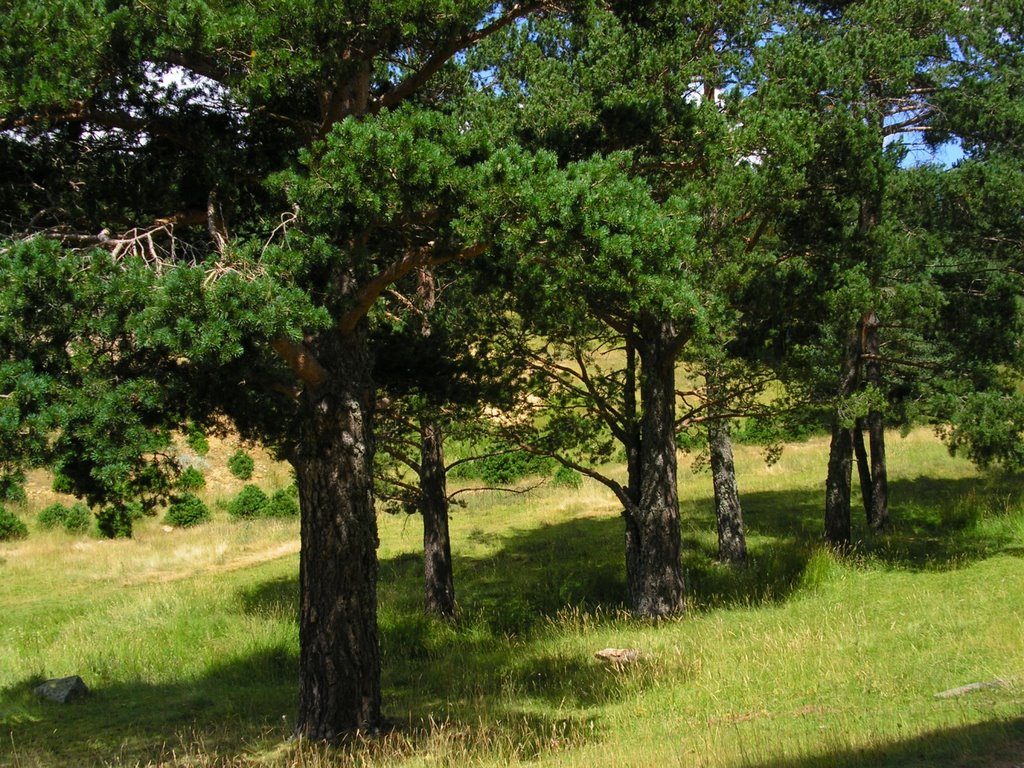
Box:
744;718;1024;768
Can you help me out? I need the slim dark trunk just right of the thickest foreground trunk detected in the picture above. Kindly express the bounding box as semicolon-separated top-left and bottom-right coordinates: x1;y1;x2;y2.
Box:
420;422;455;618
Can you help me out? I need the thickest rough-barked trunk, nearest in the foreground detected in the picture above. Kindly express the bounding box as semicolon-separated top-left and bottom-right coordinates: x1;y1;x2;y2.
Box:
294;326;381;741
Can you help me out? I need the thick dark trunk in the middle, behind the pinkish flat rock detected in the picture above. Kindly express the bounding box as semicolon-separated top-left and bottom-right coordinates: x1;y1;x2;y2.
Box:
627;321;683;618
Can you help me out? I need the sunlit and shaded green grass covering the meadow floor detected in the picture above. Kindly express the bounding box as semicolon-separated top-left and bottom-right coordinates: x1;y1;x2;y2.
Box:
0;432;1024;768
